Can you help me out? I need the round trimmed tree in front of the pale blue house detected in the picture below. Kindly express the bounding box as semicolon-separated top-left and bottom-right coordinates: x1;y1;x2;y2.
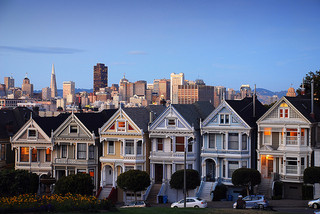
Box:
232;168;261;195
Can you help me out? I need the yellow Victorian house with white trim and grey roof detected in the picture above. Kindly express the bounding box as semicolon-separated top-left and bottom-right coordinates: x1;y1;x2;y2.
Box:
100;106;163;201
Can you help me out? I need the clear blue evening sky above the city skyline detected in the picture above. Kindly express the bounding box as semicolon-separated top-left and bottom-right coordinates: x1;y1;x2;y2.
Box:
0;0;320;91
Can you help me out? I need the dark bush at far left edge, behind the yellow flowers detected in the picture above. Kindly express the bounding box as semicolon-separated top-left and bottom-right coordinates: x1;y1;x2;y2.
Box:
0;170;39;196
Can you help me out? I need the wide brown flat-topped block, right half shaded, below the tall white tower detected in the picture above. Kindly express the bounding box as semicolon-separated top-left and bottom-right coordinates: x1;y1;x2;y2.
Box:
178;84;214;104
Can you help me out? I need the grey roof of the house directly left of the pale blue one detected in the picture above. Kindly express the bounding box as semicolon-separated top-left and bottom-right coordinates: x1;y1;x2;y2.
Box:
172;101;214;129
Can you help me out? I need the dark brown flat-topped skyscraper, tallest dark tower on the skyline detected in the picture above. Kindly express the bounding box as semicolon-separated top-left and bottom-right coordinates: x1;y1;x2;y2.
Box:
93;63;108;93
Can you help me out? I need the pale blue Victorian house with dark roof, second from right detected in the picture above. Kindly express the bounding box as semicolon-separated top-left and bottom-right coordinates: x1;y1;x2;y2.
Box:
199;98;266;200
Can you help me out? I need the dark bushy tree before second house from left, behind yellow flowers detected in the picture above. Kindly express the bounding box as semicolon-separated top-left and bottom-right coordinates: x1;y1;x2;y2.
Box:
54;173;94;195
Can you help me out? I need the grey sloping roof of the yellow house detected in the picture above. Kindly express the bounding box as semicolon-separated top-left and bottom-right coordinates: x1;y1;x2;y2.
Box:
123;105;165;131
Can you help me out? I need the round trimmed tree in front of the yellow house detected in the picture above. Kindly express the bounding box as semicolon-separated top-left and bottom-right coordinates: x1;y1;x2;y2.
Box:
117;170;150;200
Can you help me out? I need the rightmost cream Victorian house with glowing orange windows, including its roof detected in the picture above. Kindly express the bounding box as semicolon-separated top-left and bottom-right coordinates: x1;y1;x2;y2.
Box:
257;97;320;199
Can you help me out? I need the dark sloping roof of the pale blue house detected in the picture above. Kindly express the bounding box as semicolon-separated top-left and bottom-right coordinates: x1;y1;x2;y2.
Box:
226;97;267;127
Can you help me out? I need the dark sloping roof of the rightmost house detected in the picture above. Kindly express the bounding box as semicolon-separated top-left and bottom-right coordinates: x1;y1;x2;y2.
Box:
285;96;320;123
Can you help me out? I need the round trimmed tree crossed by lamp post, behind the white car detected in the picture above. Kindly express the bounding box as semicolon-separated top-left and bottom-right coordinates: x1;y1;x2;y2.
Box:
170;169;200;196
